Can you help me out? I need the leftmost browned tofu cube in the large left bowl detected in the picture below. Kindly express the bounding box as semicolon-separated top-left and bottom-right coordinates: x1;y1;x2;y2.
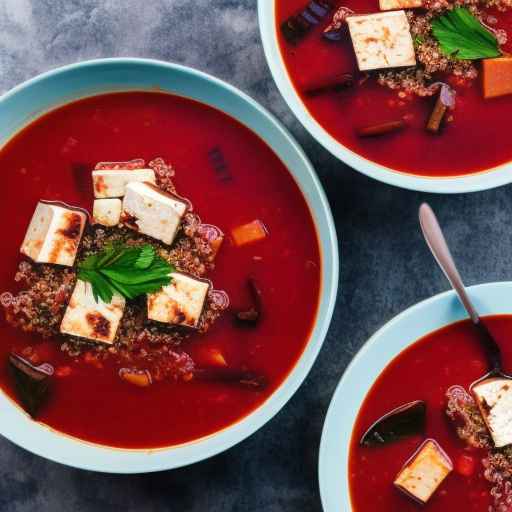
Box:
20;201;87;267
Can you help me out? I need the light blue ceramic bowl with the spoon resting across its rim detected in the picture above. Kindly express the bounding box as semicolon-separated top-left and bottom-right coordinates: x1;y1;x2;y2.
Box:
319;282;512;512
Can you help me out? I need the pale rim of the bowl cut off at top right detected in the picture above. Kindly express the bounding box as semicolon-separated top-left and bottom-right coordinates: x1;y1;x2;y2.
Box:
258;0;512;194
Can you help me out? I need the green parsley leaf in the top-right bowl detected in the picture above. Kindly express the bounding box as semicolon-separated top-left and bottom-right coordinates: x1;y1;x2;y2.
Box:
432;7;501;60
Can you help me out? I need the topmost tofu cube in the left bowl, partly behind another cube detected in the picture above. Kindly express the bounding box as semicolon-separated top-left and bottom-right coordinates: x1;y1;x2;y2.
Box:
92;169;156;199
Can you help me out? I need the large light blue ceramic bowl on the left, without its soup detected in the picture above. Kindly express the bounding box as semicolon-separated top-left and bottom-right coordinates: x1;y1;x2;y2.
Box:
0;59;338;473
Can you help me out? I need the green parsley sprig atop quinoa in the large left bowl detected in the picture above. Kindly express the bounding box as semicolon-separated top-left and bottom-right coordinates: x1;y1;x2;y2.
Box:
78;244;175;303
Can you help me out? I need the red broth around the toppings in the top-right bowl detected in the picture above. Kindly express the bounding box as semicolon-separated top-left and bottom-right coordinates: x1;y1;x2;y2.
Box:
276;0;512;176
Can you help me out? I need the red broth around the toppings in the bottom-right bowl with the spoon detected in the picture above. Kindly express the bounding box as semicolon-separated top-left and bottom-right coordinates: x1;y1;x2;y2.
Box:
349;315;512;512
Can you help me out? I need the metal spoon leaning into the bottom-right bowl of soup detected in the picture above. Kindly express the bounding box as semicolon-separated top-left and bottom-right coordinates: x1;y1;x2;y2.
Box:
419;203;506;382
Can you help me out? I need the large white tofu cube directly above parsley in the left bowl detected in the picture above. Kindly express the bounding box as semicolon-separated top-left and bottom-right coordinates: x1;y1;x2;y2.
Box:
121;182;188;245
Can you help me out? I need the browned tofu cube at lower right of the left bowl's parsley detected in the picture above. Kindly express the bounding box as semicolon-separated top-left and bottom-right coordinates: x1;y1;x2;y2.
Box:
148;272;210;328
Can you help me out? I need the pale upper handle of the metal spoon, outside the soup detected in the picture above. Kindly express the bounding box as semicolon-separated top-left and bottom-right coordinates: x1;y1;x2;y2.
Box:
419;203;480;324
